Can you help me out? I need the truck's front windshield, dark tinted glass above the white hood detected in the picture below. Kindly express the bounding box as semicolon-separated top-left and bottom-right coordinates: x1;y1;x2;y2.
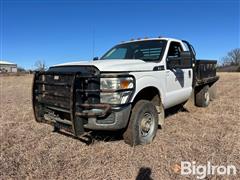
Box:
101;40;166;61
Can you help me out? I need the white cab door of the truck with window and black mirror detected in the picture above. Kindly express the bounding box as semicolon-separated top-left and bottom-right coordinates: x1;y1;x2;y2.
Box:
165;41;193;107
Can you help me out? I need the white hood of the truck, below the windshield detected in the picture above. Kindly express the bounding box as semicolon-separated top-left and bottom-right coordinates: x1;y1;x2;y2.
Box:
53;59;156;72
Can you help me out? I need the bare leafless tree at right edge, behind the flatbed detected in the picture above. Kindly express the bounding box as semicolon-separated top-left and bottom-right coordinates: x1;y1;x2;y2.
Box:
223;48;240;66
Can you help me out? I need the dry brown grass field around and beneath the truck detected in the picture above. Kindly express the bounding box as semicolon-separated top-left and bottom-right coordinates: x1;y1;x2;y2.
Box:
0;73;240;180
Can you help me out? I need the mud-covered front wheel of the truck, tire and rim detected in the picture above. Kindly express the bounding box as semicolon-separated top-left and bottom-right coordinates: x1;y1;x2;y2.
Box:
123;100;158;146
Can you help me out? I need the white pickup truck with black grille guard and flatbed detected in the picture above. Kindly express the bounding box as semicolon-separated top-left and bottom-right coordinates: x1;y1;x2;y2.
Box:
33;37;219;145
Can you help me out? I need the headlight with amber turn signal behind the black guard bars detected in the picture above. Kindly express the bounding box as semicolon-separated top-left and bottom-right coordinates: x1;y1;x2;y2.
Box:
100;77;134;104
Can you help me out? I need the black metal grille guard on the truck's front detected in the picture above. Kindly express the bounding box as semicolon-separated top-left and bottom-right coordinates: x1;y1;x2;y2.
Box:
32;67;135;136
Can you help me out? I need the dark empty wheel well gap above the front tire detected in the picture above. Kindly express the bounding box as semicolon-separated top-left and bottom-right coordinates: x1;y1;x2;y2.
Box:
133;86;161;106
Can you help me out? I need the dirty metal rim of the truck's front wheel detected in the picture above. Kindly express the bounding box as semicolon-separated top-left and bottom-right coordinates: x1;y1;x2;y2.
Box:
140;113;154;137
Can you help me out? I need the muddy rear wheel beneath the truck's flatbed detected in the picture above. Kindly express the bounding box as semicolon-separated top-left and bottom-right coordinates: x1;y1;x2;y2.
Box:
196;85;210;107
